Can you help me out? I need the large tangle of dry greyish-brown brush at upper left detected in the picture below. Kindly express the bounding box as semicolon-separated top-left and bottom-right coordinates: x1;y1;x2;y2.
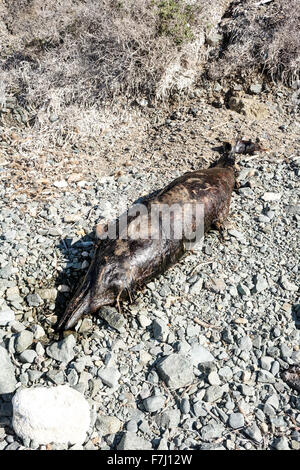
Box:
1;0;201;107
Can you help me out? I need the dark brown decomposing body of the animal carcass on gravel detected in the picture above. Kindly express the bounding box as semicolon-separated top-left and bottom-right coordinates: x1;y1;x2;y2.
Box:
57;143;264;329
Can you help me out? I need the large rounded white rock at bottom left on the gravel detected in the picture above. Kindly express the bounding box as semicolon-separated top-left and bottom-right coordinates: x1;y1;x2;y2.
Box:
12;385;90;444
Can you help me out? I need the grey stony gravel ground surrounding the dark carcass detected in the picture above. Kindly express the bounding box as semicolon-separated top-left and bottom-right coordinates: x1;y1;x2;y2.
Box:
0;86;300;450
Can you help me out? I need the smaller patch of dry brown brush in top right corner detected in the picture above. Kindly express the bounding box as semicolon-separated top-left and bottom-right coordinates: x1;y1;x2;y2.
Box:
210;0;300;85
